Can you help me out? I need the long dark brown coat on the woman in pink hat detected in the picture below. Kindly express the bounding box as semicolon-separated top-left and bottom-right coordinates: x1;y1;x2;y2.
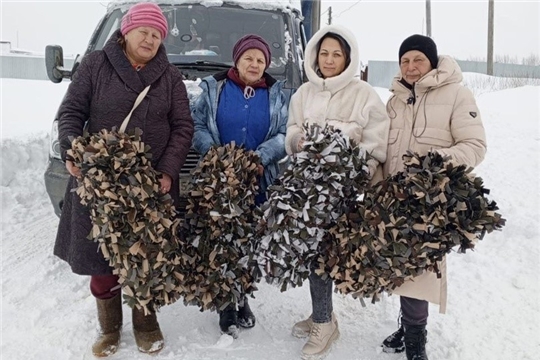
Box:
54;31;193;275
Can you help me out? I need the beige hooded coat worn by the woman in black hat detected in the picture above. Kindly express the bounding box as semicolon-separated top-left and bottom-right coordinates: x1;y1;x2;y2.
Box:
384;56;486;313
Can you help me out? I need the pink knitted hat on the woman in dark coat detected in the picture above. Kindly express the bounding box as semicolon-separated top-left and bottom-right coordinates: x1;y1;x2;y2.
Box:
120;3;169;40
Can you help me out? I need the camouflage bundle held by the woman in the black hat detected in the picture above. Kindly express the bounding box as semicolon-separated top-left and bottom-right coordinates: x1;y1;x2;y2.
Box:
324;152;505;303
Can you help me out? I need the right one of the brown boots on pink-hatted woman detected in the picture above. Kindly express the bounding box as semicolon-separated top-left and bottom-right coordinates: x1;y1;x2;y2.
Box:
133;308;164;353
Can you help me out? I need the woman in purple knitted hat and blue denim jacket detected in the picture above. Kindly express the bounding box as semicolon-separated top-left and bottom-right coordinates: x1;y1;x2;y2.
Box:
192;34;289;335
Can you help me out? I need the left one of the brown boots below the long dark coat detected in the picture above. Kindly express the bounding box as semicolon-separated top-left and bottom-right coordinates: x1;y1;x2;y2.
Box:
92;294;122;357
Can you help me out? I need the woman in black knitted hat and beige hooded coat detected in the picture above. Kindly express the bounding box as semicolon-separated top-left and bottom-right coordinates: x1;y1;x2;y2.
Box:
383;35;486;360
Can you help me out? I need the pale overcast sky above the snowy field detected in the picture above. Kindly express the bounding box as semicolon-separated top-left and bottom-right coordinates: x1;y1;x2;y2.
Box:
0;0;540;61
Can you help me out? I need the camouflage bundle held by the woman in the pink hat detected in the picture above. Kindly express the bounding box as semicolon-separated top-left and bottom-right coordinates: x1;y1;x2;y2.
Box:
68;129;181;312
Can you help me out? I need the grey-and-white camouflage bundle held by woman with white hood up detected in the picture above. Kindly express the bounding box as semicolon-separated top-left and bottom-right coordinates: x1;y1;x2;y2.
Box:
256;125;369;291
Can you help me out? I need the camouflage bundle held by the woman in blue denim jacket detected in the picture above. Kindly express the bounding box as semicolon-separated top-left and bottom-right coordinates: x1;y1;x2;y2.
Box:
176;143;260;311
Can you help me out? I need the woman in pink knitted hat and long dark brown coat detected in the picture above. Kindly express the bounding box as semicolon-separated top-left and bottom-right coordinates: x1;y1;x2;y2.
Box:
54;3;193;356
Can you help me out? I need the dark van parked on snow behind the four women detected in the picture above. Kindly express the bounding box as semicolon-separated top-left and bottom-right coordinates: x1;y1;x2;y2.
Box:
45;0;320;216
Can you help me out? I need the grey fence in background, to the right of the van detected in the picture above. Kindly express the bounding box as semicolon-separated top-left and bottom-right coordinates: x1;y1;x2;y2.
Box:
367;60;540;88
